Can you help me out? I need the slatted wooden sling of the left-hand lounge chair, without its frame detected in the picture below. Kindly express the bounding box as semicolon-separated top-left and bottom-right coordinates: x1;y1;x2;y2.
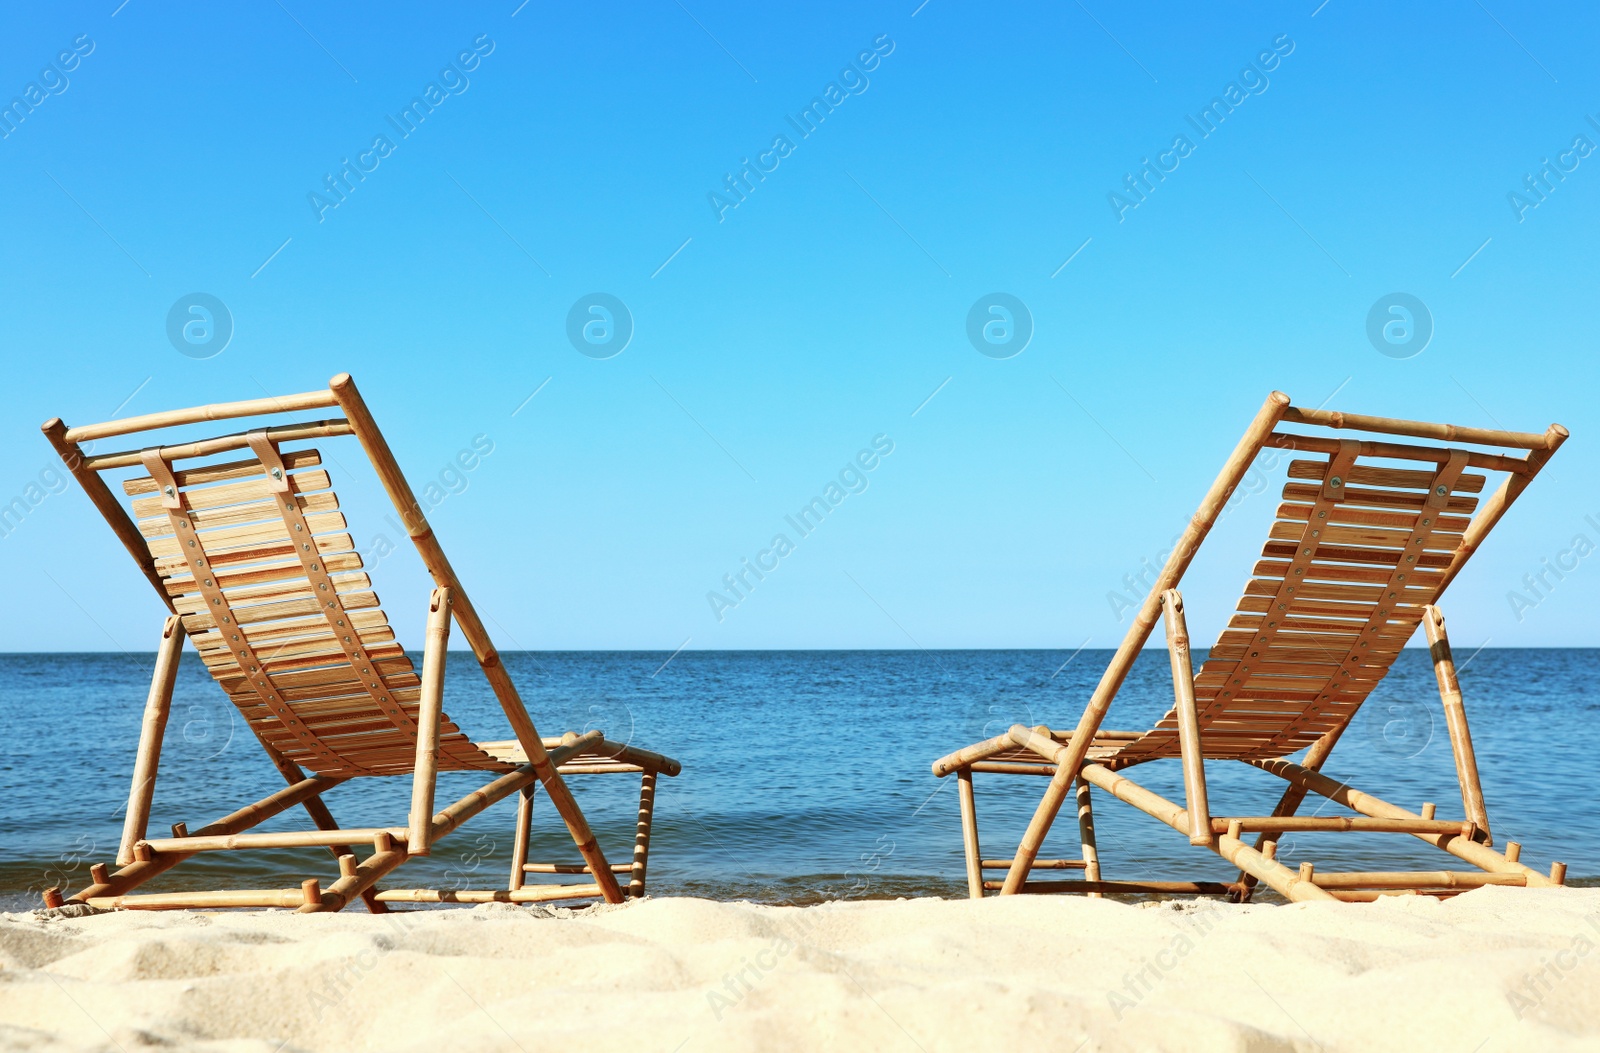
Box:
123;432;510;776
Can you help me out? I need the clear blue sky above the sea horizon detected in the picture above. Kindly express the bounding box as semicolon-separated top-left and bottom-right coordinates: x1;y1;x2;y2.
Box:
0;0;1600;651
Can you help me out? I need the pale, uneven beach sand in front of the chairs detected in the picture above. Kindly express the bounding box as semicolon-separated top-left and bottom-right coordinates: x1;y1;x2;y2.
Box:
0;888;1600;1053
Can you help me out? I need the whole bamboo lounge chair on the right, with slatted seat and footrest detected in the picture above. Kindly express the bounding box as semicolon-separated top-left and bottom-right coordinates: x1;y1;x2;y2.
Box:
933;392;1566;901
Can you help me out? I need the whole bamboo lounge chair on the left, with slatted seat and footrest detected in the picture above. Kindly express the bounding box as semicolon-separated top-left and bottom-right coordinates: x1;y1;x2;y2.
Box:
43;374;680;914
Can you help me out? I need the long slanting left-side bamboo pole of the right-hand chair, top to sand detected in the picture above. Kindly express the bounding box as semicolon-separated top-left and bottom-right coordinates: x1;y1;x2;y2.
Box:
1000;390;1290;895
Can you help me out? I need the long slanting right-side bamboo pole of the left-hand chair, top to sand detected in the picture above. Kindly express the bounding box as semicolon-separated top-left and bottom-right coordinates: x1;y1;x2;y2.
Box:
328;373;622;903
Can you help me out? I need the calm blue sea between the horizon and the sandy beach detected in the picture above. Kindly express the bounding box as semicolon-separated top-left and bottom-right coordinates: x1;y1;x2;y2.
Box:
0;650;1600;911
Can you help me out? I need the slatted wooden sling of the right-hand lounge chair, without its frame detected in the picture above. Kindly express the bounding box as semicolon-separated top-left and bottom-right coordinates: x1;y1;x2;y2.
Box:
1118;440;1486;760
